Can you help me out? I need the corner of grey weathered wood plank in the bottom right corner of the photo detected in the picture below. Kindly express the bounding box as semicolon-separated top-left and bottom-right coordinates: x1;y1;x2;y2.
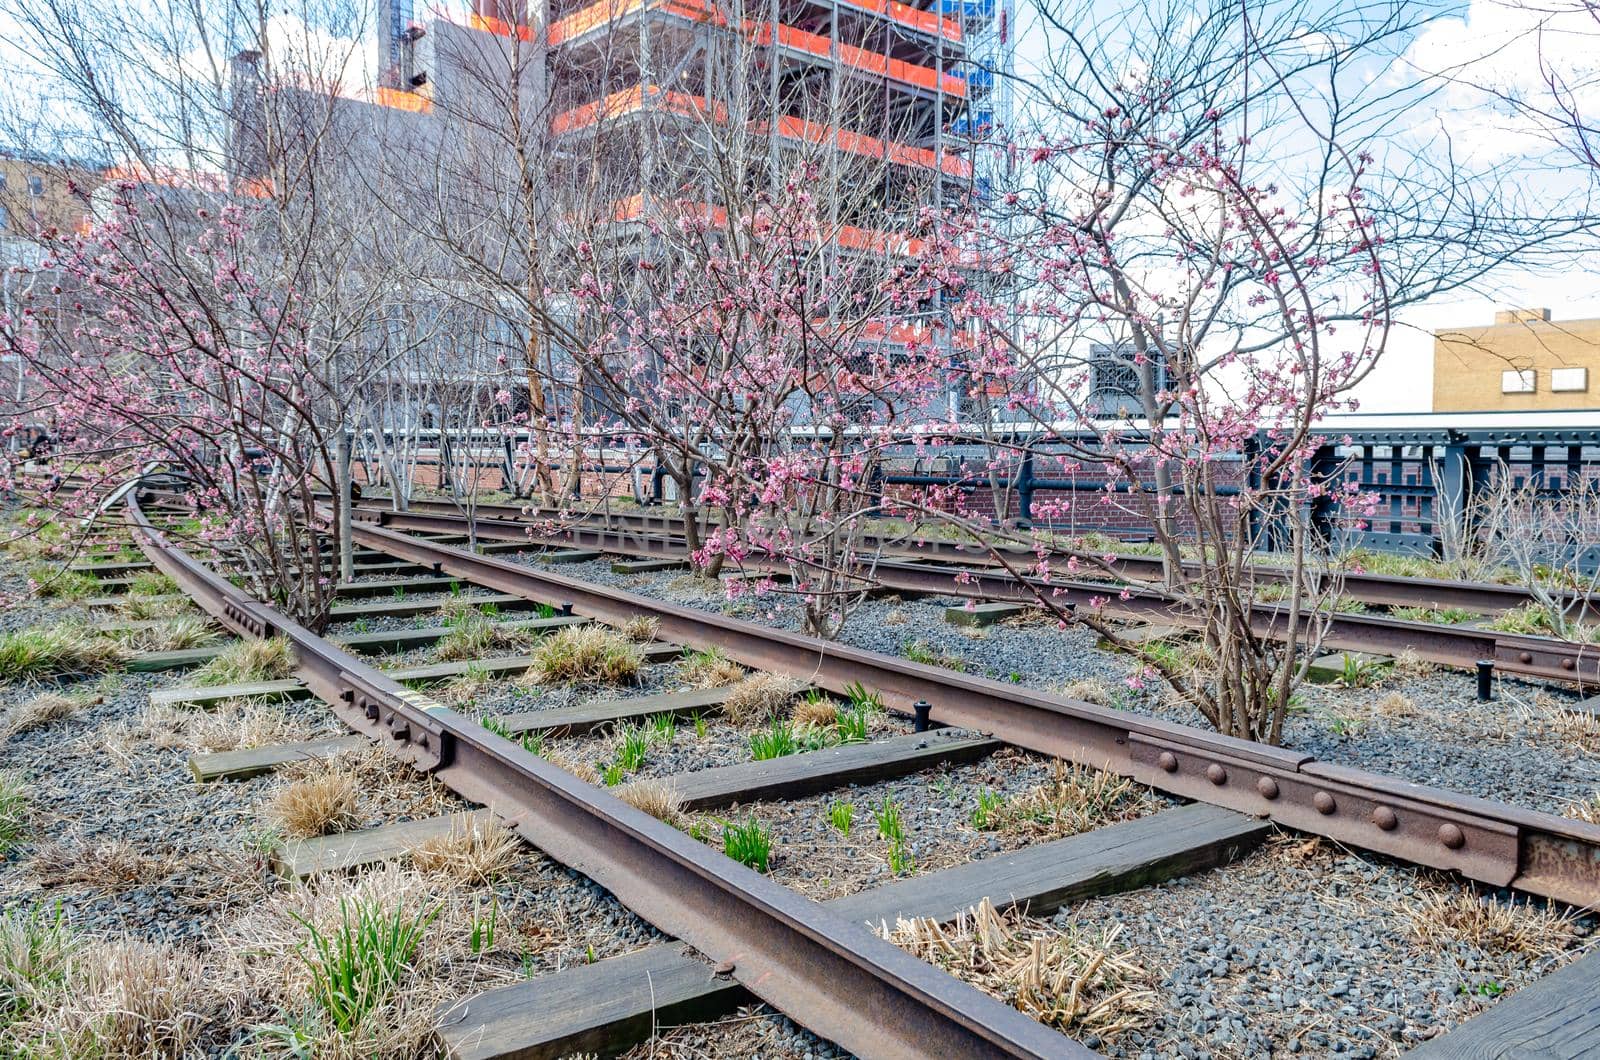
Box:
1406;953;1600;1060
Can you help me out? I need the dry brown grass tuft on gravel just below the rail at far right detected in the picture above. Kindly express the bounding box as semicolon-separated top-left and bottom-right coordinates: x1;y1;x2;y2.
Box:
1402;885;1579;959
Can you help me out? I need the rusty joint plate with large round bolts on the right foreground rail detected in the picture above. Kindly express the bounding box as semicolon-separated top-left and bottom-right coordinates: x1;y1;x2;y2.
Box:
1128;732;1522;887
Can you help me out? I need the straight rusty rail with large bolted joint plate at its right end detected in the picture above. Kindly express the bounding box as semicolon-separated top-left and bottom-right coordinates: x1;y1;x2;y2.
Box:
354;514;1600;908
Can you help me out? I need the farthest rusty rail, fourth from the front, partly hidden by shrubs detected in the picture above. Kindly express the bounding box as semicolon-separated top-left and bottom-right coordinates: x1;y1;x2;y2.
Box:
365;500;1600;618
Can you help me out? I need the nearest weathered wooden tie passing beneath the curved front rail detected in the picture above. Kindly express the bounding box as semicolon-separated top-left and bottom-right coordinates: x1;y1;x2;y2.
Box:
438;804;1269;1060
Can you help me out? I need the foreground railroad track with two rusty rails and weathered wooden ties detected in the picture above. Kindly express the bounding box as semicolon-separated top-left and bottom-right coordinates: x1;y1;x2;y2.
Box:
46;486;1600;1057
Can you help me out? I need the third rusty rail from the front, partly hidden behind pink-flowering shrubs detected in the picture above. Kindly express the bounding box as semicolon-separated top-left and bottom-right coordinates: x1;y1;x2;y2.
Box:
357;509;1600;687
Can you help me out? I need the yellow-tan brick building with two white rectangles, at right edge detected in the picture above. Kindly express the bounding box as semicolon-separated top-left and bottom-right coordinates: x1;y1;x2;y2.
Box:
1434;309;1600;412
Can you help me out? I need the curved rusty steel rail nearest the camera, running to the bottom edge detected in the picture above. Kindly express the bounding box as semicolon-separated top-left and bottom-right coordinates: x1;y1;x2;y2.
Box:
126;496;1094;1060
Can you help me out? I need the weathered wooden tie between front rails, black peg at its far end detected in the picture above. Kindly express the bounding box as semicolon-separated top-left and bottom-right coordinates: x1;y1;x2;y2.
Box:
669;732;1005;810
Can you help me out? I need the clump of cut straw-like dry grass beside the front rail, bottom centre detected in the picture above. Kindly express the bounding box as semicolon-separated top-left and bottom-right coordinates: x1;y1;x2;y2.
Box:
882;898;1155;1039
